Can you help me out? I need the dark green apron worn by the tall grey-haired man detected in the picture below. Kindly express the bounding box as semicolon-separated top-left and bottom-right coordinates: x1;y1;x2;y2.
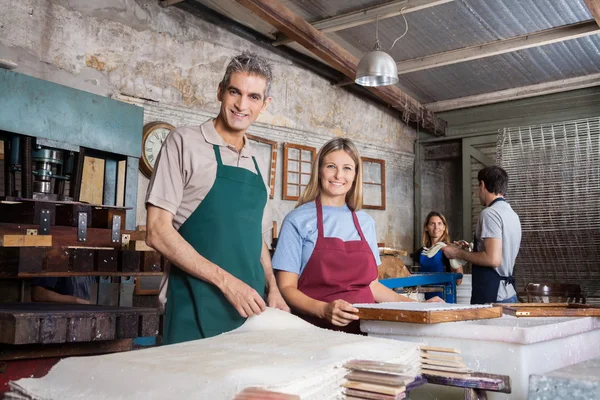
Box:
163;145;267;344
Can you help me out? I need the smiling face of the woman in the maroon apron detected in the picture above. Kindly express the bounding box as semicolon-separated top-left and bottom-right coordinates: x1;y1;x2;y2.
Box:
319;150;356;201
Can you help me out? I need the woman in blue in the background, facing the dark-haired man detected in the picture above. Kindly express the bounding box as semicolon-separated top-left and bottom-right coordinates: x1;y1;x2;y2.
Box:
414;211;463;300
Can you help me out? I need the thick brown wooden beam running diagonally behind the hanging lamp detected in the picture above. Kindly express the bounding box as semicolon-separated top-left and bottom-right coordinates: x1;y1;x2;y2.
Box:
236;0;446;136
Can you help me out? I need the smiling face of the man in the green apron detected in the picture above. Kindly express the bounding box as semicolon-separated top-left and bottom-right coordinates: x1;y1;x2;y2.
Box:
217;72;271;133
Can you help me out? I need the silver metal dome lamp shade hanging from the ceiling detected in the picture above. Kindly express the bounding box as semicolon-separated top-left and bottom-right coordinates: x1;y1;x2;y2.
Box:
354;50;398;86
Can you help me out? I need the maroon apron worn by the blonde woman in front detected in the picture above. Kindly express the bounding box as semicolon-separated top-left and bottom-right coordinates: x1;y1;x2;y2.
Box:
298;197;378;333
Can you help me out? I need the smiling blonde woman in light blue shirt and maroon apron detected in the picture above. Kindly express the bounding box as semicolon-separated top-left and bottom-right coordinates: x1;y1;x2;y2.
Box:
273;138;439;333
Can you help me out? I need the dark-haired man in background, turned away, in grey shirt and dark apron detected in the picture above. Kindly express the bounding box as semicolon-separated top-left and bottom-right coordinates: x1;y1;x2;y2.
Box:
442;165;521;304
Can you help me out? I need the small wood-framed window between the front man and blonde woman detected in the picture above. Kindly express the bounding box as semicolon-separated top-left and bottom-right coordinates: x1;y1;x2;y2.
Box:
283;143;317;200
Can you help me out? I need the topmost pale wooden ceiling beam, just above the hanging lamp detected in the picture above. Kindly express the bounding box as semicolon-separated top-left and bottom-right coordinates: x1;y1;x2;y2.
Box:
273;0;454;46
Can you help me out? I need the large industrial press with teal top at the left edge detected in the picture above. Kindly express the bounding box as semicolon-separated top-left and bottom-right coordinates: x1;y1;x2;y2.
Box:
0;69;164;393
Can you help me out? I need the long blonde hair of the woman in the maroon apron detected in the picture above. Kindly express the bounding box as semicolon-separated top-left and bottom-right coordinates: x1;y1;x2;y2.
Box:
296;138;363;211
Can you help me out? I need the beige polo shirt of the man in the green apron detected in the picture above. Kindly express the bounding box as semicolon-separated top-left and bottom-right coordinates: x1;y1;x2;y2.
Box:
146;120;273;234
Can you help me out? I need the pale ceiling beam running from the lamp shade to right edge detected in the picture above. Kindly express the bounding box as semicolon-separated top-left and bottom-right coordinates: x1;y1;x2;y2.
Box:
397;21;600;75
